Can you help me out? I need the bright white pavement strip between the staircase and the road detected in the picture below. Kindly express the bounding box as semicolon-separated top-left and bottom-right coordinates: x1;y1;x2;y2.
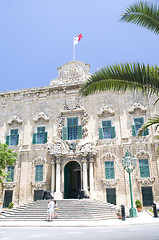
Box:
0;212;159;228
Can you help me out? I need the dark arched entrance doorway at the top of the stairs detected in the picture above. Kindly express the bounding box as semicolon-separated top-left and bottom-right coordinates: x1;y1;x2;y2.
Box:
64;161;81;199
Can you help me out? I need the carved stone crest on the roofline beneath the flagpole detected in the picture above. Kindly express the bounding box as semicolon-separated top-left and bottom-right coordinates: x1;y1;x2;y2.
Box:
50;61;90;86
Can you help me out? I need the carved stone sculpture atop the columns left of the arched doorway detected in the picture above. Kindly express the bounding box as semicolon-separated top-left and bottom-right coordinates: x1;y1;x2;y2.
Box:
48;137;69;155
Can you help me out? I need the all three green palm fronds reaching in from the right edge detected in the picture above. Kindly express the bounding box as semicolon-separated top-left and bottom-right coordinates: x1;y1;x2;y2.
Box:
81;2;159;135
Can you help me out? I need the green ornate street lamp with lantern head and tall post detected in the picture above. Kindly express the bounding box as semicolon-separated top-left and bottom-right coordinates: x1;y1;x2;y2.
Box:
122;149;137;217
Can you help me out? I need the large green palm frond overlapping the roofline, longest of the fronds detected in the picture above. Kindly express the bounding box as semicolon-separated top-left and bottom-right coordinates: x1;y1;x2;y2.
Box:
81;63;159;96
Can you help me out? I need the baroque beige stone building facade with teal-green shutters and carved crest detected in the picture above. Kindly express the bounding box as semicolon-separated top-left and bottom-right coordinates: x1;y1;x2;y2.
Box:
0;61;159;207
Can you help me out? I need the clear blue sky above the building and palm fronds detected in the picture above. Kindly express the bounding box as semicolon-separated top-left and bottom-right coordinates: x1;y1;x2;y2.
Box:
0;0;159;92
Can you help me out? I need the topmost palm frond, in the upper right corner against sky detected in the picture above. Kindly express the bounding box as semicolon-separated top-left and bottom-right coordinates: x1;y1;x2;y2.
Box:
120;2;159;34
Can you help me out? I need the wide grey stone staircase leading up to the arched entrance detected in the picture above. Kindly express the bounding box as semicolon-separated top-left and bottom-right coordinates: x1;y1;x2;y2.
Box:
0;199;117;221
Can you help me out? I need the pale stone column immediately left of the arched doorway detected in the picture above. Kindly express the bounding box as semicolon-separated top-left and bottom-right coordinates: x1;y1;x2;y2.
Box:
54;157;63;199
